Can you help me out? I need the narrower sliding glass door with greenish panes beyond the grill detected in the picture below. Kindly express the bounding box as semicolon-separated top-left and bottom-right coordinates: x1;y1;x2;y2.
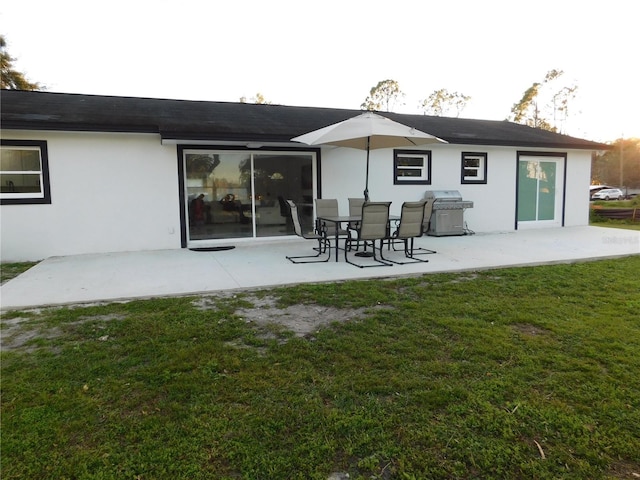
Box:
517;156;564;228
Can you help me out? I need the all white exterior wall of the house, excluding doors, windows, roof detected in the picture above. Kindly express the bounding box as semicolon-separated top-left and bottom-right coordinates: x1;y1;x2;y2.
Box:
0;130;591;262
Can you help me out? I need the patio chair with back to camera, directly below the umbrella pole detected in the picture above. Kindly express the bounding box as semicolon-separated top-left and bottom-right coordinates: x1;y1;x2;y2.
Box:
344;202;393;268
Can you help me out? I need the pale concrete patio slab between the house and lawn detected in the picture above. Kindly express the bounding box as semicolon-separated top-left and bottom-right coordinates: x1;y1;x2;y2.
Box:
0;226;640;311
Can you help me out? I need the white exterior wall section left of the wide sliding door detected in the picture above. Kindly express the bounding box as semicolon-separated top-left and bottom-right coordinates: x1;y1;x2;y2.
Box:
0;130;180;262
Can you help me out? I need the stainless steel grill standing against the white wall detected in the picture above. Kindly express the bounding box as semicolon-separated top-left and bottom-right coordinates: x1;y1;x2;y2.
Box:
424;190;473;237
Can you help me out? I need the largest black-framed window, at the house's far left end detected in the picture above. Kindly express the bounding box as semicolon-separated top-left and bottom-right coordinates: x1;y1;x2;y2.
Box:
0;140;51;205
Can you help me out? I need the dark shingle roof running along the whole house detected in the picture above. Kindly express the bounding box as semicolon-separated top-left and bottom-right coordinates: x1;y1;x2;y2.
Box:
0;90;610;150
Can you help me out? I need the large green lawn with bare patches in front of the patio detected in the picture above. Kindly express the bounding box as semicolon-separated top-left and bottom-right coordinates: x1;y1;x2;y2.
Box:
1;255;640;480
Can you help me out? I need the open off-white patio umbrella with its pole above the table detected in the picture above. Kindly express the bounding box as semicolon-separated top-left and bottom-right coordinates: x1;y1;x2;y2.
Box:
291;112;447;201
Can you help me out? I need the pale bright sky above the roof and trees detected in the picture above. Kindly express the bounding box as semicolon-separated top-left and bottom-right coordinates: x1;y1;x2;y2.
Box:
0;0;640;142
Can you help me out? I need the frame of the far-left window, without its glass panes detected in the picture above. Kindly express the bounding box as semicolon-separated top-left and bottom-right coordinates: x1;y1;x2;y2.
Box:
0;140;51;205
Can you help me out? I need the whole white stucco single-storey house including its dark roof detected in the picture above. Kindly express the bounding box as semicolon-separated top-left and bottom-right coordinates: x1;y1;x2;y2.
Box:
0;90;608;262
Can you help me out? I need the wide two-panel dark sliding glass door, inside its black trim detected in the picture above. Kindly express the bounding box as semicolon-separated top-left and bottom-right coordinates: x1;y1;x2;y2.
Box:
183;149;315;244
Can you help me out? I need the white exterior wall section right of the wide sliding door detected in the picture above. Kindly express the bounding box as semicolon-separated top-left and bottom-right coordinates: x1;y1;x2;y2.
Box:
321;145;591;233
